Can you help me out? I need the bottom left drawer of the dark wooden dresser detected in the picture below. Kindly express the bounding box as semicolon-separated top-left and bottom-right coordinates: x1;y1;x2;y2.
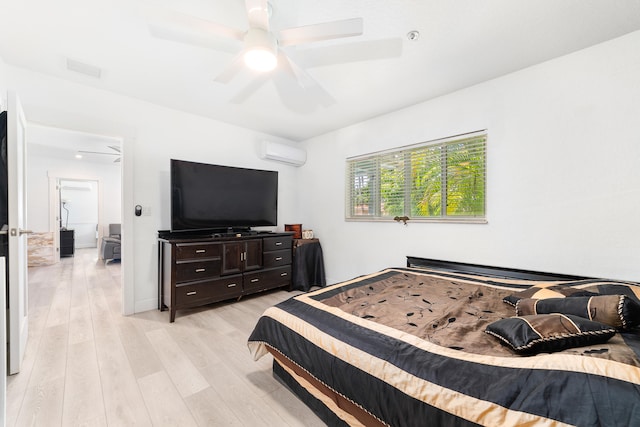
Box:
176;275;242;307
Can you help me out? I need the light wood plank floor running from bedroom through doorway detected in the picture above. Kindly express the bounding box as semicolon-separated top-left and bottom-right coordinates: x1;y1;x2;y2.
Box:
7;249;324;427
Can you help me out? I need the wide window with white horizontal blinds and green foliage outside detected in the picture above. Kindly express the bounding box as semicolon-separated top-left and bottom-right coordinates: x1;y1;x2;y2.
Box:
346;131;487;222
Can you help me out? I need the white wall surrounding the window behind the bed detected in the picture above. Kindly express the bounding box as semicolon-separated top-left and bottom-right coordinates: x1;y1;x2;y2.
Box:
298;32;640;282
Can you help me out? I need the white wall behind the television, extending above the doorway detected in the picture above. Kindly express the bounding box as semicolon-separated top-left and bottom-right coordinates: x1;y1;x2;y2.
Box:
6;66;298;312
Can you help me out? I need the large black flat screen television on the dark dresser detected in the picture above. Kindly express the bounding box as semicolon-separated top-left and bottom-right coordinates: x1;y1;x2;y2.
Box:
170;159;278;232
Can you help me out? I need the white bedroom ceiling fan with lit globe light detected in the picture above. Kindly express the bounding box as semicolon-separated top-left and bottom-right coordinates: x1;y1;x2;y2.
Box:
149;0;378;106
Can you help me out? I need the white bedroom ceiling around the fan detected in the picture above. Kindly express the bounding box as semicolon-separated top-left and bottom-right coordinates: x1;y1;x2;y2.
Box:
0;0;640;141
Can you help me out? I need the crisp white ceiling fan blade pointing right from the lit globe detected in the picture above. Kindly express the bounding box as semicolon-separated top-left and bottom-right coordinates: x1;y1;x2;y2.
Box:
278;18;363;46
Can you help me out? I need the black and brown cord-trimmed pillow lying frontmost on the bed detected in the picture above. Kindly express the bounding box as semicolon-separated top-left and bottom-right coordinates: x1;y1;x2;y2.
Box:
485;313;616;354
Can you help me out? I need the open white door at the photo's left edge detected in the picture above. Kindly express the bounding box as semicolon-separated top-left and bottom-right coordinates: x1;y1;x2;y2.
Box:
7;92;29;375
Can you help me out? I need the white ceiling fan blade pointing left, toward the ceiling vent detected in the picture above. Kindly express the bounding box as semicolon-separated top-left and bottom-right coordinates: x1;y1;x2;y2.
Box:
147;10;244;52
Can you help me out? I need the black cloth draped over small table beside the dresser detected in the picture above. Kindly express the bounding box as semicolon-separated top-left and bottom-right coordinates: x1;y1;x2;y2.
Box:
291;239;326;292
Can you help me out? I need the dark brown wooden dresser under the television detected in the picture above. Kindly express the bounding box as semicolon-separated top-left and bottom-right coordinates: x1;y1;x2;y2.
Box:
158;229;293;322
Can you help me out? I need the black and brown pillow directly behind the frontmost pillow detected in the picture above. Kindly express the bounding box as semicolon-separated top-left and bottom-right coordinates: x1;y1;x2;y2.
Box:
516;295;640;329
